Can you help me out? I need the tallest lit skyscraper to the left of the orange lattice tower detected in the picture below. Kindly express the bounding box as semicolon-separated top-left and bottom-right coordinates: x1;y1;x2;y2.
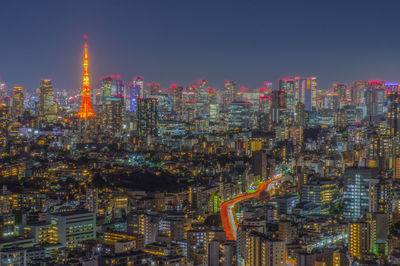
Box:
39;79;56;121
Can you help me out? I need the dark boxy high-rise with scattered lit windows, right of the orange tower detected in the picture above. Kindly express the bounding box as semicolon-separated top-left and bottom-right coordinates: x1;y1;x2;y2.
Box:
136;98;158;137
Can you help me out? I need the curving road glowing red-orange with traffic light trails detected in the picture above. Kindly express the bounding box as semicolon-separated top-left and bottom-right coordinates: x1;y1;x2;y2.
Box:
221;177;281;240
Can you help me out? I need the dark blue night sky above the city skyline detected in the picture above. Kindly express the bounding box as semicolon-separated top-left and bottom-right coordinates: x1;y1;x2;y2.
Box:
0;0;400;89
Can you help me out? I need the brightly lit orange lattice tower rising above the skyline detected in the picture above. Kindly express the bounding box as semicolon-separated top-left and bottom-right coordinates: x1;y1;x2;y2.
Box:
78;36;96;119
